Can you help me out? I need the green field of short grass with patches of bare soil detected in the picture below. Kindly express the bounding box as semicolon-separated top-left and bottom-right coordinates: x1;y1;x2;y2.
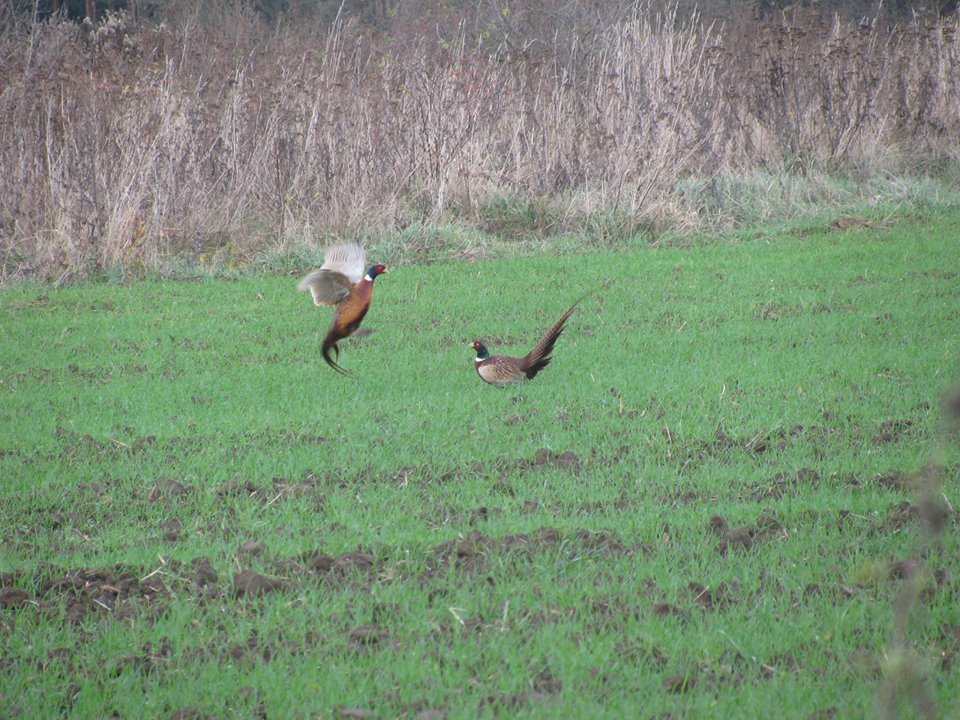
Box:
0;213;960;720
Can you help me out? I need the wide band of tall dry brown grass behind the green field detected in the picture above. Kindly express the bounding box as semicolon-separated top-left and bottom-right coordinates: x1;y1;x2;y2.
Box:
0;0;960;278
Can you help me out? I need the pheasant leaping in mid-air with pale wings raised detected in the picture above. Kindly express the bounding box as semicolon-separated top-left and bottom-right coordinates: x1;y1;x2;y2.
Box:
297;243;387;376
